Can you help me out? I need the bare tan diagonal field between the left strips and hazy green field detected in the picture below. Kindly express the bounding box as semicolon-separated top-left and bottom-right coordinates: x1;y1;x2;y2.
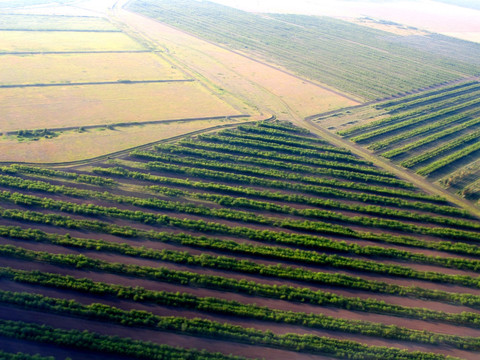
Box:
116;10;356;118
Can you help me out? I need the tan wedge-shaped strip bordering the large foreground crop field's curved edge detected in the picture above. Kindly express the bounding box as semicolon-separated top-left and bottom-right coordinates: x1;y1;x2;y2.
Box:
0;119;253;163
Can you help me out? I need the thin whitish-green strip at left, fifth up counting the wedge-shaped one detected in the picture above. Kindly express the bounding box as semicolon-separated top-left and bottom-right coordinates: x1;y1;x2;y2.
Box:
0;13;120;31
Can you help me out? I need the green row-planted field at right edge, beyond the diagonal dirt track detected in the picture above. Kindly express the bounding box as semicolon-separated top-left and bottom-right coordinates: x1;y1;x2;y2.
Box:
334;81;480;199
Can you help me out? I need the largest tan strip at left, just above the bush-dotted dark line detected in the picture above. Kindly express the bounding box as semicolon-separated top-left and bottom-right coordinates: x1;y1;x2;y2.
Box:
0;82;239;132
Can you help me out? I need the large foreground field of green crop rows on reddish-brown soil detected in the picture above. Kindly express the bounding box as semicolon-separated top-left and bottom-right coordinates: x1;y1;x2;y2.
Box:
0;122;480;360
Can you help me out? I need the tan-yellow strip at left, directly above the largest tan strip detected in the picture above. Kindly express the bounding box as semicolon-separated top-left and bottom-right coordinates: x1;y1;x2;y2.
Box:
0;53;186;85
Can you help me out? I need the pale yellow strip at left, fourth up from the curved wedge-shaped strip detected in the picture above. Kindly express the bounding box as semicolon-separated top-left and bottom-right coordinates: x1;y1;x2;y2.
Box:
0;31;144;53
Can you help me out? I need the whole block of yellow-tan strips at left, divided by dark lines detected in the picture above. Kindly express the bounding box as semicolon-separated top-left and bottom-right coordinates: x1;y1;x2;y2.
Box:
0;7;253;162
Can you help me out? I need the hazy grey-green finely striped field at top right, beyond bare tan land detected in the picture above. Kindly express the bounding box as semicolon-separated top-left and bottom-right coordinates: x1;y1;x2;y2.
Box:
128;0;480;99
